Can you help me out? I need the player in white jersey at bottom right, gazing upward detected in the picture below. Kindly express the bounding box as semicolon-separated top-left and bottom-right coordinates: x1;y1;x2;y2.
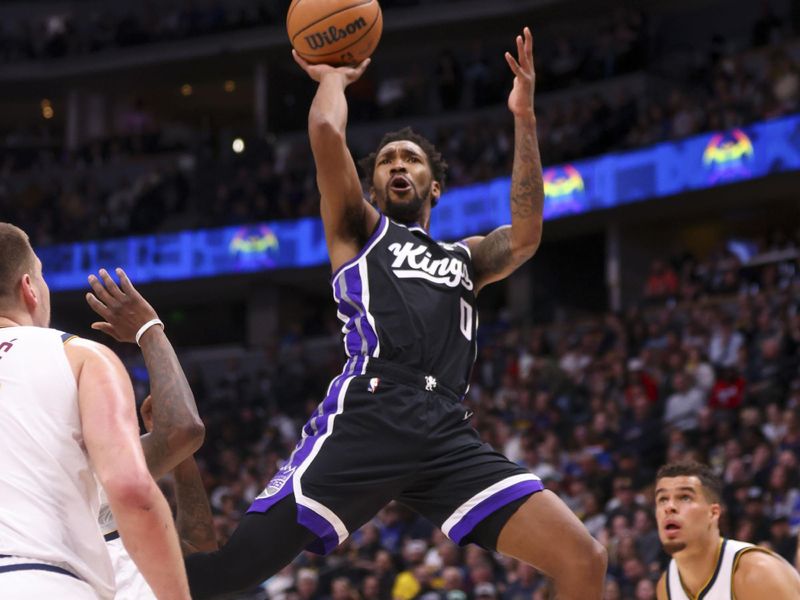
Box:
656;462;800;600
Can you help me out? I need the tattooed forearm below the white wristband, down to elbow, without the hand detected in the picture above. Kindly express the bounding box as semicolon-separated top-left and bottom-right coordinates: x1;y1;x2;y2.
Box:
142;334;202;479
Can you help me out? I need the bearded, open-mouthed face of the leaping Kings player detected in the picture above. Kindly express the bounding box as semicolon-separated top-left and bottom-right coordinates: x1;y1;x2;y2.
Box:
370;140;441;223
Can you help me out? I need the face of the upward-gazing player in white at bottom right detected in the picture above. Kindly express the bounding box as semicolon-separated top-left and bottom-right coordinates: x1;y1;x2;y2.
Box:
656;475;720;555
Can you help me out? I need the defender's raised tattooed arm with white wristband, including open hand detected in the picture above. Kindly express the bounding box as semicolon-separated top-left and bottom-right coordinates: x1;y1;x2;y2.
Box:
86;269;205;479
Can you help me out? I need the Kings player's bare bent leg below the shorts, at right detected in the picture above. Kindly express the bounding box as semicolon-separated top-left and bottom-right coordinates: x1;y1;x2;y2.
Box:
496;490;607;600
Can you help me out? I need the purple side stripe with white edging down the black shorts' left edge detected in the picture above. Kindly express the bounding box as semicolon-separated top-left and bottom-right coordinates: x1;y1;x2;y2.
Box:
247;356;365;512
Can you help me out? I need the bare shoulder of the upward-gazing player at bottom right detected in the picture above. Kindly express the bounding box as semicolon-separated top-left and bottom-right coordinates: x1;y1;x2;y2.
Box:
733;551;800;600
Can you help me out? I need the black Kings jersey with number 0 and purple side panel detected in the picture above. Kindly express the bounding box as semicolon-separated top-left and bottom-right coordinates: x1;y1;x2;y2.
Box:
332;215;478;395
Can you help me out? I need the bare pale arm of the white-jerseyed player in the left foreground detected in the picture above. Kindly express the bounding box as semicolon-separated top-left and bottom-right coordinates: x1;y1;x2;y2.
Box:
65;340;189;599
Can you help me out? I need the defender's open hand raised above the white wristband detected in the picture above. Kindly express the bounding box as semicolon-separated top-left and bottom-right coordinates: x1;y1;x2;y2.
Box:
86;268;158;343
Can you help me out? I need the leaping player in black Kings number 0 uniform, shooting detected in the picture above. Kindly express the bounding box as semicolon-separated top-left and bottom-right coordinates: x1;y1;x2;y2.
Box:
187;28;606;600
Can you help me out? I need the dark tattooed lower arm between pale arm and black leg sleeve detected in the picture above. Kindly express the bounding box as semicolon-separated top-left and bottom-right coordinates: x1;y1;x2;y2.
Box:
174;458;217;554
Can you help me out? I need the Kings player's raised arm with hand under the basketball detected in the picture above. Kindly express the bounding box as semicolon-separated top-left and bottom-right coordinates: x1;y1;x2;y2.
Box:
292;50;379;270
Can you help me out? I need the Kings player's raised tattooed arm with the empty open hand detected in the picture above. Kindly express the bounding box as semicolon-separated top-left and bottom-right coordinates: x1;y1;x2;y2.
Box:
467;27;544;290
